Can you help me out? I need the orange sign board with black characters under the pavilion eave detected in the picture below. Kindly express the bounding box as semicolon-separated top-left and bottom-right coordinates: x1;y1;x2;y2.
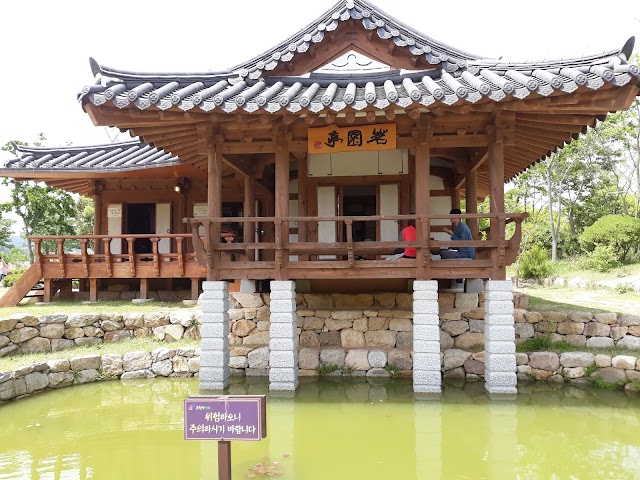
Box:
308;123;396;154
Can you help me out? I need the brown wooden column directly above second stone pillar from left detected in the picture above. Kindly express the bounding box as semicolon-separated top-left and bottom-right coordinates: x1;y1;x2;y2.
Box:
274;127;289;280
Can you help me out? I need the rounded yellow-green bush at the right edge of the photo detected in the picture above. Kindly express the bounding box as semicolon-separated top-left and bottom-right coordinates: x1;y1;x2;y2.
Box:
580;215;640;262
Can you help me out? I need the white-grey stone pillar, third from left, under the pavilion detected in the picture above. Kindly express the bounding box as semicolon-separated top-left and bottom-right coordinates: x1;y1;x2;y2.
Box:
413;280;442;393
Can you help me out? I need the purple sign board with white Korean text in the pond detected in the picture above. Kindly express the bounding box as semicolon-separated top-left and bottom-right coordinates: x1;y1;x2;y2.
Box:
184;395;267;441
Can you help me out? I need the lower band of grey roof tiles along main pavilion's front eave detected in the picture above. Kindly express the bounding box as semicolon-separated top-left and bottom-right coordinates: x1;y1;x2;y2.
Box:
80;52;640;113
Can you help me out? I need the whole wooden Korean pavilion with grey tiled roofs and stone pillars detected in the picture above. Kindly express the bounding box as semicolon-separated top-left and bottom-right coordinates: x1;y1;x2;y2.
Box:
0;0;640;391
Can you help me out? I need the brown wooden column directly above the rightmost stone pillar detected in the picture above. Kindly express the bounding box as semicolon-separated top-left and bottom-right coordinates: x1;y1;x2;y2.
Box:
487;125;506;280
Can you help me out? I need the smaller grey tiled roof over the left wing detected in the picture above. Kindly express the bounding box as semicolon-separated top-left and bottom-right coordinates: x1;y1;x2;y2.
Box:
5;140;183;173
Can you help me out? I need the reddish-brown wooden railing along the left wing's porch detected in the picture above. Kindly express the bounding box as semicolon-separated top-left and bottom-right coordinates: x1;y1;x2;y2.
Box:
29;234;205;278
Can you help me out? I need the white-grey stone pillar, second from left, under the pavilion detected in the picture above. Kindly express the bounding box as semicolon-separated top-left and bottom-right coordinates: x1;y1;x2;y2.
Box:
269;280;298;391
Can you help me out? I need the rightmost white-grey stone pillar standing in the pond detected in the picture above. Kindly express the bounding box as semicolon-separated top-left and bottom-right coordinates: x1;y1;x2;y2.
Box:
484;280;517;394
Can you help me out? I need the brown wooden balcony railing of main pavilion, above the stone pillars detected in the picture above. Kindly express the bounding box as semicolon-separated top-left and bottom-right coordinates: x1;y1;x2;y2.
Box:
185;213;527;279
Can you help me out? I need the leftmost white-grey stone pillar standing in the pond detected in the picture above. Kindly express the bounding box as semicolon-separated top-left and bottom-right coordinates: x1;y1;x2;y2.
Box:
200;281;230;390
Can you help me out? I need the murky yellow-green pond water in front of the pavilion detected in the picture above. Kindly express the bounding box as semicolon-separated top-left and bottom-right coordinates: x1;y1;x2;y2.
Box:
0;379;640;480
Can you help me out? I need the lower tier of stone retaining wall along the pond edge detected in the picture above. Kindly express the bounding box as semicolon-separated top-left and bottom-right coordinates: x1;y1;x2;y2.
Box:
0;347;640;403
